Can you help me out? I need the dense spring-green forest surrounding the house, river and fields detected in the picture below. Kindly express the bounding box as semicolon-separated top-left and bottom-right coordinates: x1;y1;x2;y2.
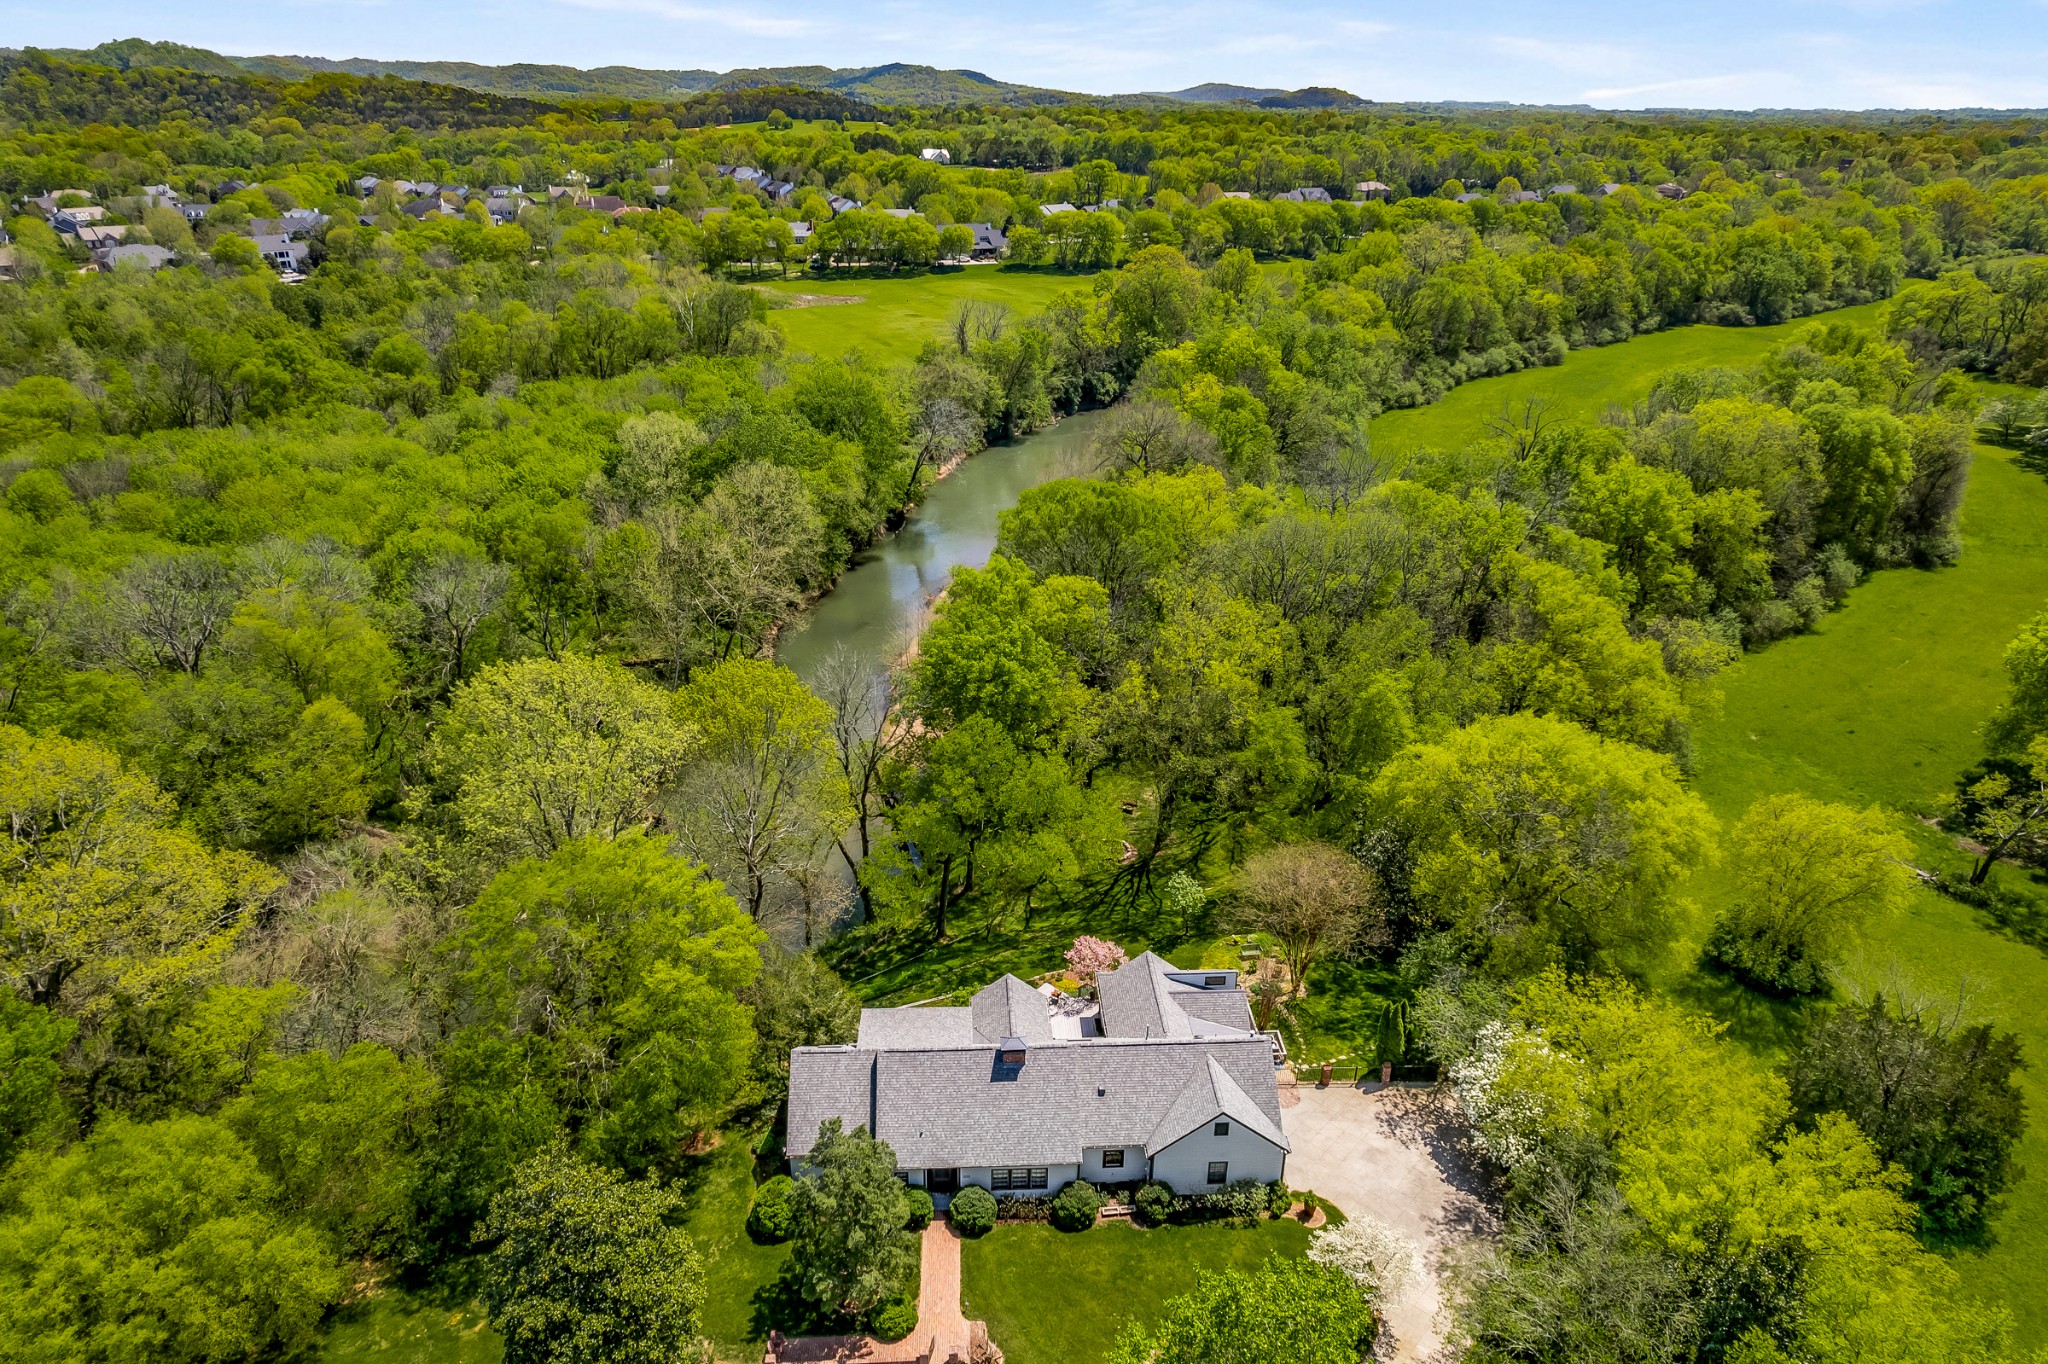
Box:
0;53;2048;1364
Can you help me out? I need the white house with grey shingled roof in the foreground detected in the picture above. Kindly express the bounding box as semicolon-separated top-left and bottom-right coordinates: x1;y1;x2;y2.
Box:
786;952;1290;1206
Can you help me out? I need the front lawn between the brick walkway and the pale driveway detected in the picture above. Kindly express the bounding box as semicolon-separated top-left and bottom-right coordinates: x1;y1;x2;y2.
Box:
961;1219;1309;1364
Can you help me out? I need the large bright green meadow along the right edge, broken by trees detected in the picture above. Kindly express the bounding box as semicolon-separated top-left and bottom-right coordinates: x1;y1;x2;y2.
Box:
1671;436;2048;1346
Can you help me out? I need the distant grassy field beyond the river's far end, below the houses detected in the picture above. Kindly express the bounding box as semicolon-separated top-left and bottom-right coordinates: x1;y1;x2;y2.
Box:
760;264;1090;365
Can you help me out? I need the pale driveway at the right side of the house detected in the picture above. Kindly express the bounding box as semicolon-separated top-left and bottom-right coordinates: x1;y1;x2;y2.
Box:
1280;1083;1497;1364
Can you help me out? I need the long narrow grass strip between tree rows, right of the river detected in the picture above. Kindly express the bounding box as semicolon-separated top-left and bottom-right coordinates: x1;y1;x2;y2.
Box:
1372;303;1884;455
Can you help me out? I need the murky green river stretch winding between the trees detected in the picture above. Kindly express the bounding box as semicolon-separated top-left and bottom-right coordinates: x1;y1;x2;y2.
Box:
774;412;1102;682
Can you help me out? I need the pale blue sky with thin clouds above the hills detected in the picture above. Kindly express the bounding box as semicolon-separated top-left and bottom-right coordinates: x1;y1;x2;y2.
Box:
0;0;2048;109
